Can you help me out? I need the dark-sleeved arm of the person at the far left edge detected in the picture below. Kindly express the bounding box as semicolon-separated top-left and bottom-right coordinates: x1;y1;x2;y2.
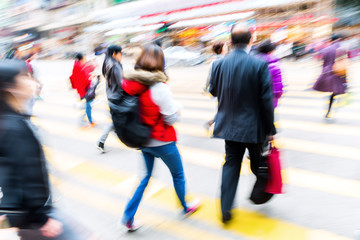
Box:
6;124;51;225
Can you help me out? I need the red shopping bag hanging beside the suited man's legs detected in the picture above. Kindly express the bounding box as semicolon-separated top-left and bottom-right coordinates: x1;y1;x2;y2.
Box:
265;144;283;194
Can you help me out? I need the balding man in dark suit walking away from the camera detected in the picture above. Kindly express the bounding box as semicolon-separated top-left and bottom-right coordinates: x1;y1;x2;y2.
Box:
209;25;276;223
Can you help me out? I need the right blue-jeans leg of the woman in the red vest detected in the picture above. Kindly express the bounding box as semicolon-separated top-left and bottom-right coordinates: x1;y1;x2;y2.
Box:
152;142;187;212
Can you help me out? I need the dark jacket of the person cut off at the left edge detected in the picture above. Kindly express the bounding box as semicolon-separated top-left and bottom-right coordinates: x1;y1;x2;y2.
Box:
0;106;51;228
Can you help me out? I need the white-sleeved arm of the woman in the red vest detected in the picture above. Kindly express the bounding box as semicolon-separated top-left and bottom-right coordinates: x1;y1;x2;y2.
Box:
151;83;180;126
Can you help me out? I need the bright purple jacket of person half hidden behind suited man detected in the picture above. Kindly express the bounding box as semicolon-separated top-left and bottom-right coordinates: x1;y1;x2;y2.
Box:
258;54;283;108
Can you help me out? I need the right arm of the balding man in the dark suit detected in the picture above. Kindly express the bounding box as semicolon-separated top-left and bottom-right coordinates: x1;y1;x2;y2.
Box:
258;62;276;136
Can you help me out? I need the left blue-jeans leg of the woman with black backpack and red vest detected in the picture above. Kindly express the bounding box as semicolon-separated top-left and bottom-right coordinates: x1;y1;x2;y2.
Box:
123;149;154;224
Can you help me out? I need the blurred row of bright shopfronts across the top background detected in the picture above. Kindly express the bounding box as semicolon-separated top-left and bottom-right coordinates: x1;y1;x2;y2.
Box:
0;0;359;57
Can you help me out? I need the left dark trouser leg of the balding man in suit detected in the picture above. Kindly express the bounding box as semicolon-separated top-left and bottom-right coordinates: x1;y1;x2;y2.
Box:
220;141;245;222
